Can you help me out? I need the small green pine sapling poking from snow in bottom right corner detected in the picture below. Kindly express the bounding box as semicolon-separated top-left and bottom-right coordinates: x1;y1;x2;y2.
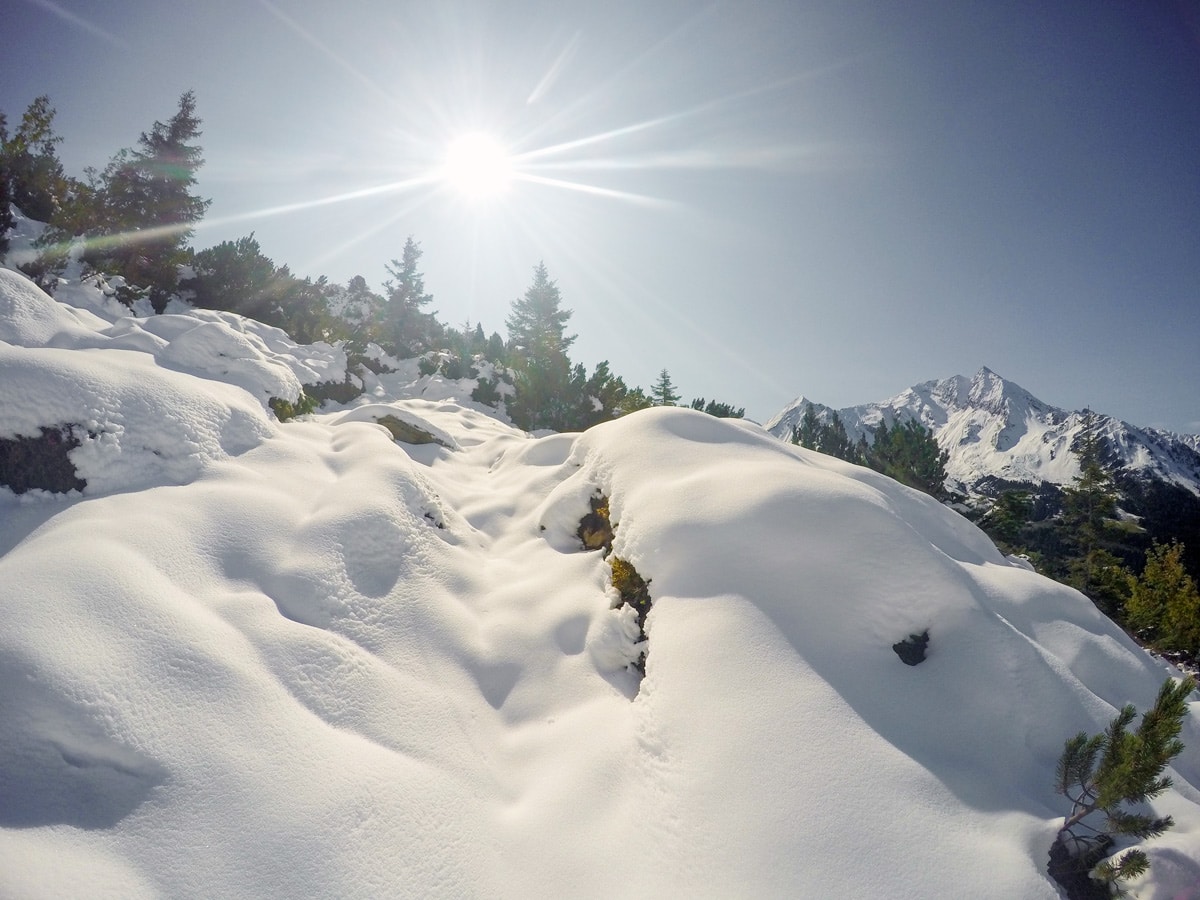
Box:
1051;677;1196;893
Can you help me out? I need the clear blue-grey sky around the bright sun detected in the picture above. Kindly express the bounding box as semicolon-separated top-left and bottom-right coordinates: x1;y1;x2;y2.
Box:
0;0;1200;432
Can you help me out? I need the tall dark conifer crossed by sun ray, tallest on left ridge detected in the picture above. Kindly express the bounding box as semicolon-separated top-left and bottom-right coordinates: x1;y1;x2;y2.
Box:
88;91;210;312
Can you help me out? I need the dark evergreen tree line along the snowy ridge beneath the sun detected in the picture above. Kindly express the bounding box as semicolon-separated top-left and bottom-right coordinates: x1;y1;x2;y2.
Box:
0;91;745;431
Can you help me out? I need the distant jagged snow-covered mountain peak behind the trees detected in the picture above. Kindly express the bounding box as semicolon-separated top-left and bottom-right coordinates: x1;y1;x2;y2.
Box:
767;368;1200;494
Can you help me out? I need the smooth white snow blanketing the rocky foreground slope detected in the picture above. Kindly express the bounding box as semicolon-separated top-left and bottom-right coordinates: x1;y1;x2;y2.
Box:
7;271;1200;900
